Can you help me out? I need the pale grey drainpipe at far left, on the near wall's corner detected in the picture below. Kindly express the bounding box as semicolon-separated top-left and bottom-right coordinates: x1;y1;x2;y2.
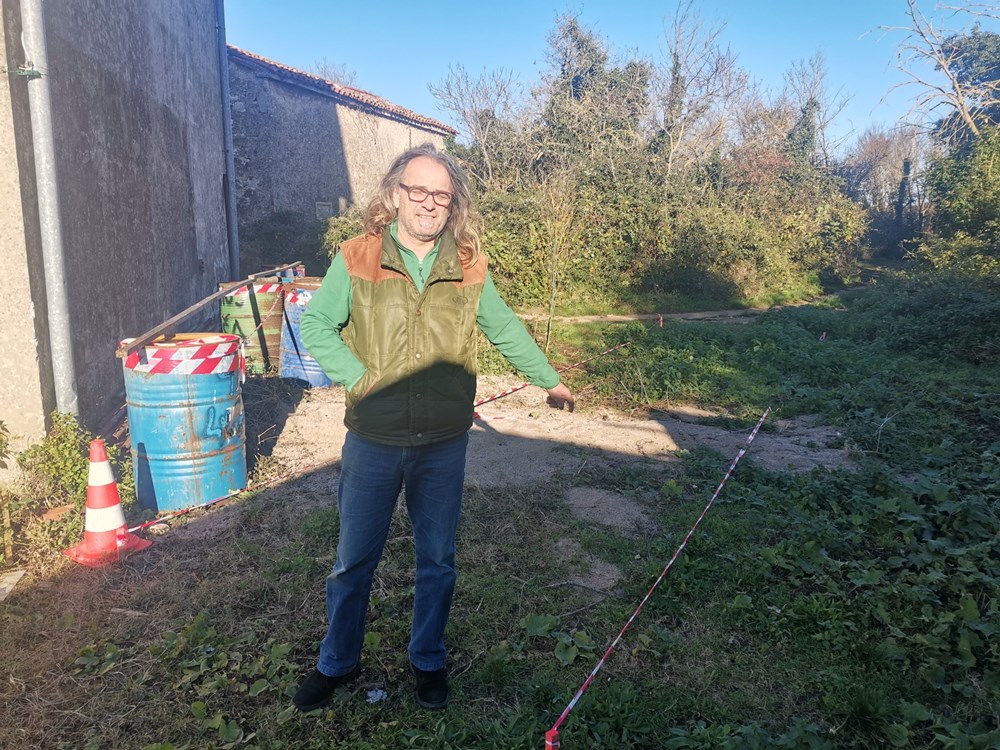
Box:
21;0;79;415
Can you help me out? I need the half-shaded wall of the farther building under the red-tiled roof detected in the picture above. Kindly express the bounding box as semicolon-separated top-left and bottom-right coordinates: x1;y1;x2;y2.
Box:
229;55;444;236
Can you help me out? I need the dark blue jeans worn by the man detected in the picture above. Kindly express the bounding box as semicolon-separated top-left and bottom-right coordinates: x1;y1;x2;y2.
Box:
319;432;469;677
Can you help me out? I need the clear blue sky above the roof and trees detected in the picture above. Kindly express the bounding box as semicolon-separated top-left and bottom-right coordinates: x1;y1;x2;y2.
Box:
225;0;997;150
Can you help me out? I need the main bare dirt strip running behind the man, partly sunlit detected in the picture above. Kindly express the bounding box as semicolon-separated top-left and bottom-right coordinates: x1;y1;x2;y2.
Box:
273;377;849;496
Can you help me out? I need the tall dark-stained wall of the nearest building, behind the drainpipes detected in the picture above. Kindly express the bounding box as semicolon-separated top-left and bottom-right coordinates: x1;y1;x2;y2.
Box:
0;0;230;464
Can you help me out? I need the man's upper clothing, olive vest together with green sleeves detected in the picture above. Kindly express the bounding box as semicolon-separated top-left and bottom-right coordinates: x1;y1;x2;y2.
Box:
300;226;559;446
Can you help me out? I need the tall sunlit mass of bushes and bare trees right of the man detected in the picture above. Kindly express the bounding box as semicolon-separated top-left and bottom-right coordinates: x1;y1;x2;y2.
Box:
439;16;866;312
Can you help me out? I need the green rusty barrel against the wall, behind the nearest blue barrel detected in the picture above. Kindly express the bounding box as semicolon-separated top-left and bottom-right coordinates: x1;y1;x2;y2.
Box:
219;277;284;374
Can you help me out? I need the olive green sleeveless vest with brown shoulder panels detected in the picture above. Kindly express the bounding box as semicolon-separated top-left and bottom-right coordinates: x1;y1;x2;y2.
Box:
340;230;487;446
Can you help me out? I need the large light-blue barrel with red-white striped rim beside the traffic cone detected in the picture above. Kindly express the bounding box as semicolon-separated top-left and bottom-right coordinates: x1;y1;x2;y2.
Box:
122;333;247;513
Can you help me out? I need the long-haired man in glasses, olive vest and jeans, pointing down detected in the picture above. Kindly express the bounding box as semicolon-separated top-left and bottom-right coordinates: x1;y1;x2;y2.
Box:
292;144;574;711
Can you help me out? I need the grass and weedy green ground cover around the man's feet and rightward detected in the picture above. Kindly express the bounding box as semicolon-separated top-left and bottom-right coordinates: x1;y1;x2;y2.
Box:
0;268;1000;750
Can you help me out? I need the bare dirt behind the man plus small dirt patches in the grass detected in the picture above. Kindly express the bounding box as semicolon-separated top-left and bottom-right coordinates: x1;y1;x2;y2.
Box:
173;377;850;591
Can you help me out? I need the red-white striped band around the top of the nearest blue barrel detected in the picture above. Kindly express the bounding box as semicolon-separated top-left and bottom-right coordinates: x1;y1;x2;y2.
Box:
121;333;244;375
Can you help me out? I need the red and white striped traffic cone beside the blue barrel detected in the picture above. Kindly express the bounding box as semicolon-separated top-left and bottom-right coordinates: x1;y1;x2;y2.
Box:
63;438;152;568
